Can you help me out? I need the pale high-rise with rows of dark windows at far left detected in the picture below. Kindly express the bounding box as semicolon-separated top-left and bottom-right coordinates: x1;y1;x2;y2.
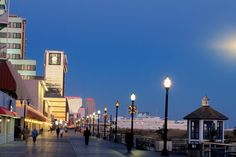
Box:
0;13;36;80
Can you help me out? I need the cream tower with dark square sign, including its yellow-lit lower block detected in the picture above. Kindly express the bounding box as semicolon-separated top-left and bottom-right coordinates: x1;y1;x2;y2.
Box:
44;50;69;121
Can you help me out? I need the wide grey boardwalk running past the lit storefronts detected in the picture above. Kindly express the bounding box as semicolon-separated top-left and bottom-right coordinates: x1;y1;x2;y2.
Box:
0;131;186;157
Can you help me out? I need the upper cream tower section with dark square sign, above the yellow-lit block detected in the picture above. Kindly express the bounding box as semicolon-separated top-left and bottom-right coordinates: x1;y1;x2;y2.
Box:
44;50;67;97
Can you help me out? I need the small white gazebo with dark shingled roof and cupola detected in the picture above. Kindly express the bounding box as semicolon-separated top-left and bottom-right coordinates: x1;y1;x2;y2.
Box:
184;96;228;147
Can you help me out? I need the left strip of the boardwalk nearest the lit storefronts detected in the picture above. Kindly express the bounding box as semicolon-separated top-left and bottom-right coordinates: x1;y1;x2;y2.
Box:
0;133;76;157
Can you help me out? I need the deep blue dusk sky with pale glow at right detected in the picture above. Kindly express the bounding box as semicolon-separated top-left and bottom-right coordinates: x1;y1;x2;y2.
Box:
10;0;236;127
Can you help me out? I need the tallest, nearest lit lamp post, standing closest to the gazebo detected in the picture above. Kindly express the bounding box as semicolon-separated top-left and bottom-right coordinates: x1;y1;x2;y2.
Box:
161;77;172;156
